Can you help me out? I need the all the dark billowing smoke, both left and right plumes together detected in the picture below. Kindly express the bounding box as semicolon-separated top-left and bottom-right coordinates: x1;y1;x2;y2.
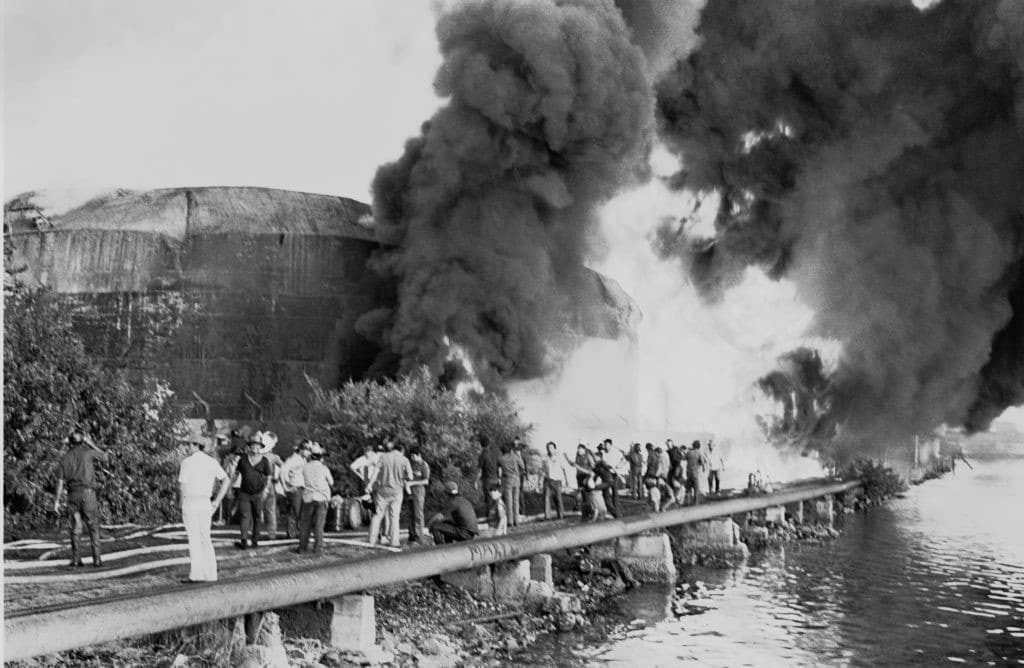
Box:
362;0;1024;458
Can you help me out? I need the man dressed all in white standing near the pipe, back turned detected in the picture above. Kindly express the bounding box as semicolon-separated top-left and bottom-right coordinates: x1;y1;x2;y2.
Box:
178;441;228;582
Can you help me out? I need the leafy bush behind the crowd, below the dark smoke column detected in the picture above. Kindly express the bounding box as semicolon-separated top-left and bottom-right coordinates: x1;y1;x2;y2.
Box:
310;368;531;501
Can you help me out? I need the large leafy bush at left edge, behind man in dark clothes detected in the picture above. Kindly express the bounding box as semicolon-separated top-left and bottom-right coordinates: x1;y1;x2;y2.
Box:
3;244;184;537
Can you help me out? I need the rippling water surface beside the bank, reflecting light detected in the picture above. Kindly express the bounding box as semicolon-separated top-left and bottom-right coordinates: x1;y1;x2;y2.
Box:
529;458;1024;666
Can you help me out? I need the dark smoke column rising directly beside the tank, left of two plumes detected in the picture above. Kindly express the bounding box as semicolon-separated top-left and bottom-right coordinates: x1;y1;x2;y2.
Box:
360;0;654;387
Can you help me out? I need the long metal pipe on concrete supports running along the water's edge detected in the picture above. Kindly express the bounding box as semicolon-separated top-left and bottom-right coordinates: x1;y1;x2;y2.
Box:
4;482;860;661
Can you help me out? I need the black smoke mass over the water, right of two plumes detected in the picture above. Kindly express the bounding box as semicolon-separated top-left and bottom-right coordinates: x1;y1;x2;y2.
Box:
657;0;1024;446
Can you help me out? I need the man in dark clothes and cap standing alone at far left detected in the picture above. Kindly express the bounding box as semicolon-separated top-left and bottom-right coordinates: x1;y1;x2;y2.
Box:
53;429;110;567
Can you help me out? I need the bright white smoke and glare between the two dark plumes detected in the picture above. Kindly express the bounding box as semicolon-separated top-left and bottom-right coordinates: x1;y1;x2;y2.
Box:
510;146;835;487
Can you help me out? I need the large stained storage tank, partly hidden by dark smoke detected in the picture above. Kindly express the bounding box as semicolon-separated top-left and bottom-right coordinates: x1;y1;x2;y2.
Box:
4;187;637;420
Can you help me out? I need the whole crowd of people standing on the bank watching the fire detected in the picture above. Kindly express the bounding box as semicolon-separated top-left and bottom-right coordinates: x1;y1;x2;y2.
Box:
54;429;725;582
